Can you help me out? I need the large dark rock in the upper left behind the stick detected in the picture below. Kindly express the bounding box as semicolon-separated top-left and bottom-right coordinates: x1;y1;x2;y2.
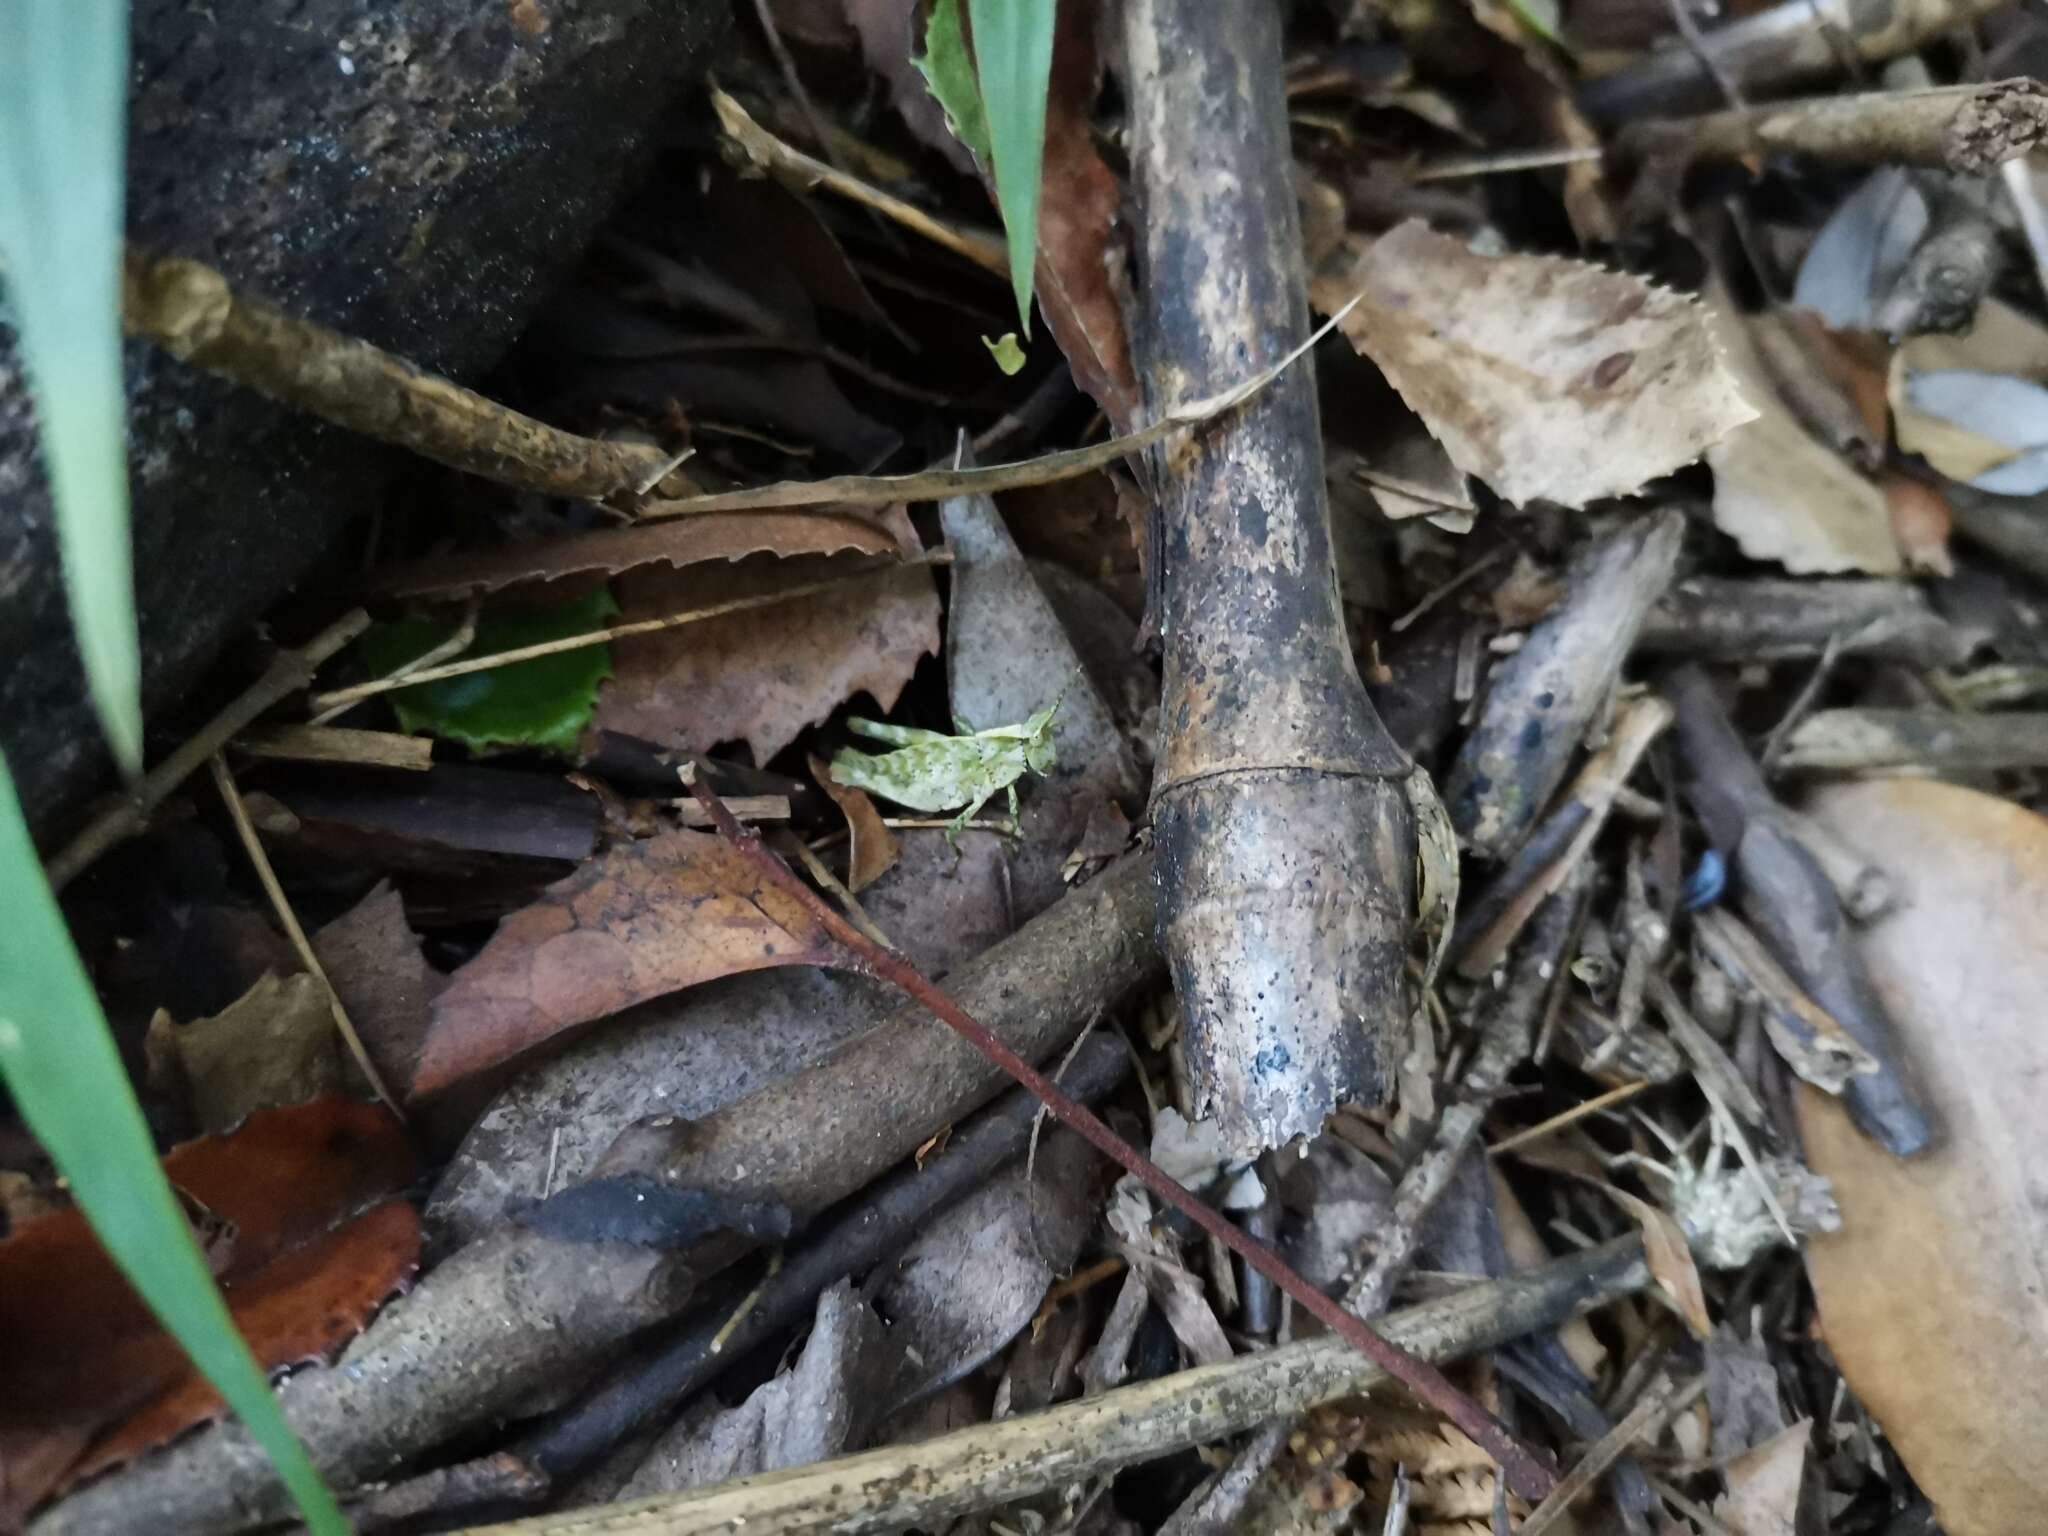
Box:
0;0;729;827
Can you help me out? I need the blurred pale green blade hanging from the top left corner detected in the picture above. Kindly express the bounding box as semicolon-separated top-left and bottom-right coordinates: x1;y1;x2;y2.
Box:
0;0;141;774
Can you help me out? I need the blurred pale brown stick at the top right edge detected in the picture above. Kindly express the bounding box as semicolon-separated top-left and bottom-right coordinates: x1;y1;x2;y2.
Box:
1579;0;2005;123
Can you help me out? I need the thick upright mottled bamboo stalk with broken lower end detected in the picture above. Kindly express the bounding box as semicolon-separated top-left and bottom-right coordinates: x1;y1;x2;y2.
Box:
1124;0;1415;1149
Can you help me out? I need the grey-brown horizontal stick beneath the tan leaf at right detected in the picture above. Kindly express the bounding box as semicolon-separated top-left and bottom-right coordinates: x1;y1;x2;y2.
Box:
1636;577;1966;668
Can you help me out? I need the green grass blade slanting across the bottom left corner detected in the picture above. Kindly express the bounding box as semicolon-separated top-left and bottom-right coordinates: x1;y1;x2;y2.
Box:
0;782;348;1536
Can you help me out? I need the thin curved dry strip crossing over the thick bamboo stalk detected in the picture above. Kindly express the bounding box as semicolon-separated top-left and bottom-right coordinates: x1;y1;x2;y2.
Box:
641;295;1364;518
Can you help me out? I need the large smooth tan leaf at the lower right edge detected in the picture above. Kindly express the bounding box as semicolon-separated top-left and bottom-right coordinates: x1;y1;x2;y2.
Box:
1800;778;2048;1536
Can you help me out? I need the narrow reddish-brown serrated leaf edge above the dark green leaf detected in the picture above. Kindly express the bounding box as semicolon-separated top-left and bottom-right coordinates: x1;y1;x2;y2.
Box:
381;510;899;598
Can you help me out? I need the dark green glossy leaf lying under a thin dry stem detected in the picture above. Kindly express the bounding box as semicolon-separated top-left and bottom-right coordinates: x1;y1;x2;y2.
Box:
358;588;618;756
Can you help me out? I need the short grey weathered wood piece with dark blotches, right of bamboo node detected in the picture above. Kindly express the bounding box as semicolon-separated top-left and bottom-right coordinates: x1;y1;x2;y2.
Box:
1444;512;1686;858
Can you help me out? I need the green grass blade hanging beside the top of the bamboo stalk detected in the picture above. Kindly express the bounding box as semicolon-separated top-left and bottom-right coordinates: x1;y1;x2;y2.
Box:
967;0;1056;336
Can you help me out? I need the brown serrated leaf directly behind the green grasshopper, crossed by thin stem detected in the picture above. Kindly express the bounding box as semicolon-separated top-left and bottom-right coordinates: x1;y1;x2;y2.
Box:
598;508;938;764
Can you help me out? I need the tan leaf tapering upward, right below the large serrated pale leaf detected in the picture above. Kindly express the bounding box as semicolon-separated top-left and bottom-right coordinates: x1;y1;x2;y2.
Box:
1706;303;1901;575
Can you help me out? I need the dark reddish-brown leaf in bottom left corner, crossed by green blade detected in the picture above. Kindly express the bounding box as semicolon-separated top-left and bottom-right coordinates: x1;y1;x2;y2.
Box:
0;1100;420;1528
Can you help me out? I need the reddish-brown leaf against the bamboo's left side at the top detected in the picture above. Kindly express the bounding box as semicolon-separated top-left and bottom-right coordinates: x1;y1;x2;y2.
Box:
1036;0;1141;432
